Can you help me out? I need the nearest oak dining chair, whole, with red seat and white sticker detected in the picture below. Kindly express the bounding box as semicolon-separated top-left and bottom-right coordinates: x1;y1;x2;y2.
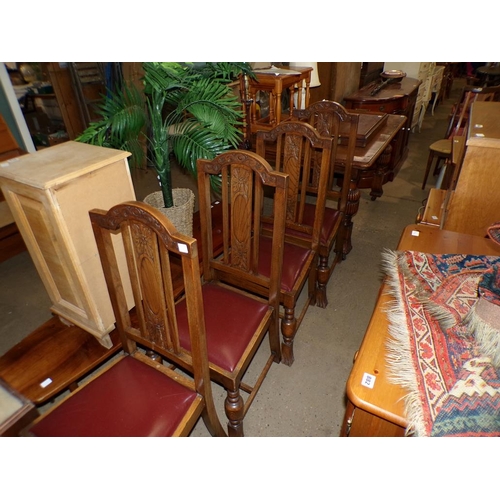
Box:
27;201;226;437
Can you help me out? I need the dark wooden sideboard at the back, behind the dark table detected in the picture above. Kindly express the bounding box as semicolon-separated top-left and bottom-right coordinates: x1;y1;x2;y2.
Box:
344;74;421;187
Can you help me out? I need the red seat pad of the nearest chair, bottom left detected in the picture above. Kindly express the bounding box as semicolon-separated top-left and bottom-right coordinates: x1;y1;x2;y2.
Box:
30;356;197;437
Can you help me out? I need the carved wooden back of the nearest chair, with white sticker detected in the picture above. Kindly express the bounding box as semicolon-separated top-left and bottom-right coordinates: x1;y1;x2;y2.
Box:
89;201;224;435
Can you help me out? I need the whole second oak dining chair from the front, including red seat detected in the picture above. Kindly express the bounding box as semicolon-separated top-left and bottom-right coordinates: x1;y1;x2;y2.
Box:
197;150;288;436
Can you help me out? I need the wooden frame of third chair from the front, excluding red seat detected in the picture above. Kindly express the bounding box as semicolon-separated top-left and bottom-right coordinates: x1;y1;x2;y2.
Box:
256;120;333;365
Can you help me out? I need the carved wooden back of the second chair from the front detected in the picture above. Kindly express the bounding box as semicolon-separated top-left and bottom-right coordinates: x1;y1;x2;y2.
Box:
197;150;289;325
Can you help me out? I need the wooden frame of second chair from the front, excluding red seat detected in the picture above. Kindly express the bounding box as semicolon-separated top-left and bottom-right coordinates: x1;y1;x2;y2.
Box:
197;150;288;436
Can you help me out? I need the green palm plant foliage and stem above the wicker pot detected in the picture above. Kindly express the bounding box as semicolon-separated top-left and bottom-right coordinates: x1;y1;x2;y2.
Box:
79;62;253;208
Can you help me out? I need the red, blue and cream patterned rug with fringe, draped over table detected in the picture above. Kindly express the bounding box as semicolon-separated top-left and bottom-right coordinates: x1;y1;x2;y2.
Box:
383;250;500;436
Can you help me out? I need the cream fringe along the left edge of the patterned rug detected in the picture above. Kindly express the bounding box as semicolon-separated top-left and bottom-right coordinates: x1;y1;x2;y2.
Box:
382;249;426;436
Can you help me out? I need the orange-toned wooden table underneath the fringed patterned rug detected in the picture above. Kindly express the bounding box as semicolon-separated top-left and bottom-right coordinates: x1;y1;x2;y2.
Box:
341;224;500;437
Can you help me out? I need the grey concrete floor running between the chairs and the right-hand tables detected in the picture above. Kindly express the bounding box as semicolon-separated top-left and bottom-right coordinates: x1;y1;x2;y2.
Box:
0;81;463;437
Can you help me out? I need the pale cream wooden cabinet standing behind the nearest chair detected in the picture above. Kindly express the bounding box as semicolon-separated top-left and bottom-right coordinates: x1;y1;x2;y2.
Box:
0;141;135;347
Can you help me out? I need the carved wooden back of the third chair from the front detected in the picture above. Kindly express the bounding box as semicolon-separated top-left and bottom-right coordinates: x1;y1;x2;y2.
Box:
256;120;333;252
